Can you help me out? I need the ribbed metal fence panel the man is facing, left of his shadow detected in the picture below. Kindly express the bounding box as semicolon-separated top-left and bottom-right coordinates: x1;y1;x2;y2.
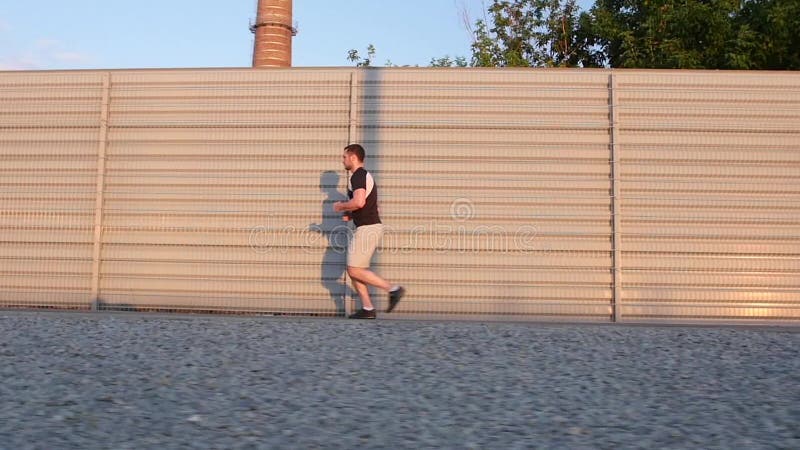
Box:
100;71;350;314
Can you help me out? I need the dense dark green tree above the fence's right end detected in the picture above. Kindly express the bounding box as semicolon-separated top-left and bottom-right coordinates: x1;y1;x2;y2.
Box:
588;0;800;69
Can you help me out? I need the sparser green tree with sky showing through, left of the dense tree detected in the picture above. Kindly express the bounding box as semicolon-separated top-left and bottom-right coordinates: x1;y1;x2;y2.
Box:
472;0;603;67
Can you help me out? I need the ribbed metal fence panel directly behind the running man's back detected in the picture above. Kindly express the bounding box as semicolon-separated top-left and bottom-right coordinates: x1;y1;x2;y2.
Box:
356;70;611;320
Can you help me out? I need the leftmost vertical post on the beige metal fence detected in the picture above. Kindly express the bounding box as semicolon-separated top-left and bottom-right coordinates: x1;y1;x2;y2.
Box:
91;72;111;310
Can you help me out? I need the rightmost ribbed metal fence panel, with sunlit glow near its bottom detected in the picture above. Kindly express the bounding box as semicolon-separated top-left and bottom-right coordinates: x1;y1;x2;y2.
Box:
617;72;800;320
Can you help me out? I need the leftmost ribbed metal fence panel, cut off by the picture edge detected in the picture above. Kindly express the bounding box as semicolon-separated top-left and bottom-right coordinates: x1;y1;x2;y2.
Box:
0;73;103;308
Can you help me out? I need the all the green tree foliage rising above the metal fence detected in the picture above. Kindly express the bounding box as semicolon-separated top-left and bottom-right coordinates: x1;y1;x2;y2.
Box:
348;0;800;70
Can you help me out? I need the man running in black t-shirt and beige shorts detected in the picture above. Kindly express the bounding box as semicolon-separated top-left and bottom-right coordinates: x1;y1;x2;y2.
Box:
333;144;405;319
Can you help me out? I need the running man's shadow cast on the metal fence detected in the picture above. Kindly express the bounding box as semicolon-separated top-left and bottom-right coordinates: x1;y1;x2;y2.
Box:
308;170;351;316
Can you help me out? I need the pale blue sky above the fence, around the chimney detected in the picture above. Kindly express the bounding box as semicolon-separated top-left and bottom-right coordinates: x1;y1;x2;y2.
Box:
0;0;588;70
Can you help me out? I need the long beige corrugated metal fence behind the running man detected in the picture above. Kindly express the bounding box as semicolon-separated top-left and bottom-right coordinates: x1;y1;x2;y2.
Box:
0;68;800;322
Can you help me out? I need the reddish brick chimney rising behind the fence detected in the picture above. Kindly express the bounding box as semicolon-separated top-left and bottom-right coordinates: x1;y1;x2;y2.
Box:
250;0;297;67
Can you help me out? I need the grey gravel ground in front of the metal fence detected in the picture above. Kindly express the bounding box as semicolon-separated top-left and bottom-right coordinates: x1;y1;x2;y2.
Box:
0;311;800;449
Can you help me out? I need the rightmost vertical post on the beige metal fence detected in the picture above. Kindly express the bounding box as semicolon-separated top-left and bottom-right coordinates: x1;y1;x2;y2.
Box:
608;72;622;322
